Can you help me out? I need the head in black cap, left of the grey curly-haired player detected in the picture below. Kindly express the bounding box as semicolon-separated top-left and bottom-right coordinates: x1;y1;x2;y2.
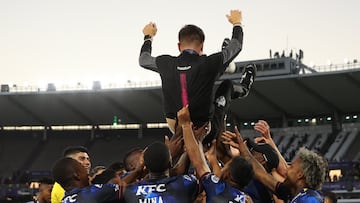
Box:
246;139;279;172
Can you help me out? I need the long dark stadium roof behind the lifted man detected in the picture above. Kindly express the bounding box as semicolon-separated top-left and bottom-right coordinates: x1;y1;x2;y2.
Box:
0;64;360;126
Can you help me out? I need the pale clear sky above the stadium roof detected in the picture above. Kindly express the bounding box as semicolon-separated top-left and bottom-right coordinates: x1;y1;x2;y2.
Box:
0;0;360;85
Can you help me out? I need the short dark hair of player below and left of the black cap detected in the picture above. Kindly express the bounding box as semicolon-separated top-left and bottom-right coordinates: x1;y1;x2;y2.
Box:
229;156;254;189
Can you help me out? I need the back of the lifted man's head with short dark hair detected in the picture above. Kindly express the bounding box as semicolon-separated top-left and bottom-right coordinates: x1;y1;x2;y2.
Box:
178;24;205;54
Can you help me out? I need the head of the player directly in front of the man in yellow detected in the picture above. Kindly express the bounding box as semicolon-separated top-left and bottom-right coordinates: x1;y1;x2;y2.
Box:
52;157;89;191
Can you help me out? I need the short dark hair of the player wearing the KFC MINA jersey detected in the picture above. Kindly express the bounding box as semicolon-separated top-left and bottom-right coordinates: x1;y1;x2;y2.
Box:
144;141;171;173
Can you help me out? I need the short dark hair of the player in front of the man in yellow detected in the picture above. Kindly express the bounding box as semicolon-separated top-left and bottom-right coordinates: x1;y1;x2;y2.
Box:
52;157;80;187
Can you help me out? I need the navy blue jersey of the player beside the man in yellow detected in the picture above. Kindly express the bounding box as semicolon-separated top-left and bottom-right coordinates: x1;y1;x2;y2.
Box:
61;184;121;203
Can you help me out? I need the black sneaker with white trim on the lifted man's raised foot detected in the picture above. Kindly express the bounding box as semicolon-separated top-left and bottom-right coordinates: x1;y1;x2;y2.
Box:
232;64;256;99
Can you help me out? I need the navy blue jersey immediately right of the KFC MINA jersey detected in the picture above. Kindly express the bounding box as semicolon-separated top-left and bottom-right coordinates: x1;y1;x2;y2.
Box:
201;173;245;203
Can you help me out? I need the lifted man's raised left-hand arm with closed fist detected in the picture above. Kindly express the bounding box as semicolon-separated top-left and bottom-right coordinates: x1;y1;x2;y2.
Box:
139;22;158;72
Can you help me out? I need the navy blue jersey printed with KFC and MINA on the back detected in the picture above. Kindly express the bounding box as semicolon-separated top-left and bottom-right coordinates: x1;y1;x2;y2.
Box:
124;175;198;203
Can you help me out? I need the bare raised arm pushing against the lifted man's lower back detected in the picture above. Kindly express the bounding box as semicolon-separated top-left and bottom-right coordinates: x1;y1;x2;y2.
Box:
177;106;210;179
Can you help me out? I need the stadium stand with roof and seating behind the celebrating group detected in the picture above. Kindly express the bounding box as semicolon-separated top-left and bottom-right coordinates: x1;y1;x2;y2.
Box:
0;58;360;202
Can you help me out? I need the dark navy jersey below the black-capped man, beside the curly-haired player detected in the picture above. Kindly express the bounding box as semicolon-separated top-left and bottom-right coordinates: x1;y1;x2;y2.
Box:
244;179;274;203
